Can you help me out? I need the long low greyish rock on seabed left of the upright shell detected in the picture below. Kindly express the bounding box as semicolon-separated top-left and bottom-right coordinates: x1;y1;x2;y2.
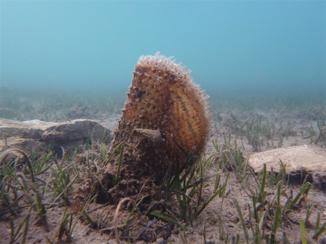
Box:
0;119;111;151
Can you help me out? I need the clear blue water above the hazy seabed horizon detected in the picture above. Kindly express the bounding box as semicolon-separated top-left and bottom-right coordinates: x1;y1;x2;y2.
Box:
0;0;326;103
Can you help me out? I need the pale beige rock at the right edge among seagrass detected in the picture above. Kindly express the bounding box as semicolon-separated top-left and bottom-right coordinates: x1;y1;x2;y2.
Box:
249;145;326;190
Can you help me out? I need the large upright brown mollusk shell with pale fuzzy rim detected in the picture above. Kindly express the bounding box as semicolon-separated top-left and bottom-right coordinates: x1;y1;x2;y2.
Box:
113;54;209;173
